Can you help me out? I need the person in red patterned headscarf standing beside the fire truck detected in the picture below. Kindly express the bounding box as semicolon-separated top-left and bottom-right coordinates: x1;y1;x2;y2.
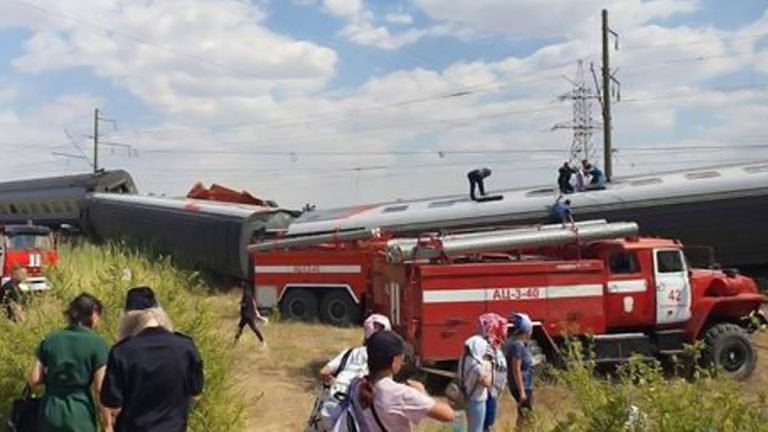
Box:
477;313;507;431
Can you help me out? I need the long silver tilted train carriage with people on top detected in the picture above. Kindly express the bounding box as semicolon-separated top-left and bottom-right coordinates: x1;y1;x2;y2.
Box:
287;162;768;273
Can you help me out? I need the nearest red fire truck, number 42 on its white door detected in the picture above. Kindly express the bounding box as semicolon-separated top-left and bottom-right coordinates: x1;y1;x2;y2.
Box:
371;234;766;379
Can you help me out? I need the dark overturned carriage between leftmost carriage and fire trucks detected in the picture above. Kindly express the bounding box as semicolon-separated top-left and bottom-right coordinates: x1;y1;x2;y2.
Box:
83;193;296;279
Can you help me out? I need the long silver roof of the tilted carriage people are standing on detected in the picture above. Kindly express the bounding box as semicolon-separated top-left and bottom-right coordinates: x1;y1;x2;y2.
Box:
287;161;768;235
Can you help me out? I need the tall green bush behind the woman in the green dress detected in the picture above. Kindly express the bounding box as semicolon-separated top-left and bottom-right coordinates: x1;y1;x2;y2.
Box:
0;243;247;432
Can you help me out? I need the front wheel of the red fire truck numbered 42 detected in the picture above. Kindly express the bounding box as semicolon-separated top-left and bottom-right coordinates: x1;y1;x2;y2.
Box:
704;323;757;380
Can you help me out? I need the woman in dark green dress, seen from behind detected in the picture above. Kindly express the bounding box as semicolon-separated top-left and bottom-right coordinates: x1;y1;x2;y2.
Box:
27;294;112;432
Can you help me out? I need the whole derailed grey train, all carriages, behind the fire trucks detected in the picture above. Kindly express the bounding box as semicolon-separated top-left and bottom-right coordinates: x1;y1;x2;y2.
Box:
0;161;768;279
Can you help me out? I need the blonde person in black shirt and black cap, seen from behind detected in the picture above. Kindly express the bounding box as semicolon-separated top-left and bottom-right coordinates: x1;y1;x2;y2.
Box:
100;287;203;432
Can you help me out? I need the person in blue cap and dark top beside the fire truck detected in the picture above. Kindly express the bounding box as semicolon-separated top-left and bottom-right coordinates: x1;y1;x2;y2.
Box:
504;313;533;430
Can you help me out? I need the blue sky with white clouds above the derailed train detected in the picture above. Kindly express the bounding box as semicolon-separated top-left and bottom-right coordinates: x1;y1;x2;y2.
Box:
0;0;768;207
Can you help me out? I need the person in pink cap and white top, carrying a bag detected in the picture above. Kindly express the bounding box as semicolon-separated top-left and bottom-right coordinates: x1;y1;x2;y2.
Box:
305;314;392;432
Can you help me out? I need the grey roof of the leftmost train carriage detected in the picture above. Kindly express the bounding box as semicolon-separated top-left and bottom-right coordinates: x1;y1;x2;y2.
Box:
0;170;136;193
